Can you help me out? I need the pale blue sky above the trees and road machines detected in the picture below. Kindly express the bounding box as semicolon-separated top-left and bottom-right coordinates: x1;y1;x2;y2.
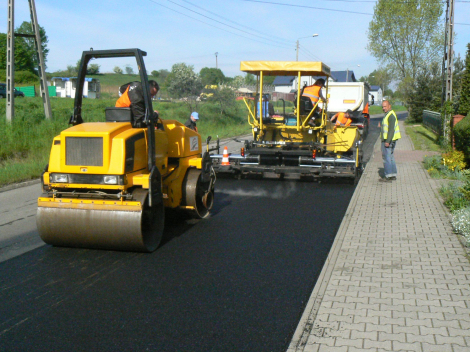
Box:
0;0;470;77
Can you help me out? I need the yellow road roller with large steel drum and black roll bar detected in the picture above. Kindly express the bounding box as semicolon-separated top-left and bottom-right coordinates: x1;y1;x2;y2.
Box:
36;49;215;252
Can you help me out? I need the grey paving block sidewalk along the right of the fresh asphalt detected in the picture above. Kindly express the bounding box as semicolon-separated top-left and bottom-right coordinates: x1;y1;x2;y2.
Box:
288;124;470;352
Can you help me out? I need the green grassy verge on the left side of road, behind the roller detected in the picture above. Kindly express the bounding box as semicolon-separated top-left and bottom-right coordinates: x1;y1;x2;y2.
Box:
0;97;251;187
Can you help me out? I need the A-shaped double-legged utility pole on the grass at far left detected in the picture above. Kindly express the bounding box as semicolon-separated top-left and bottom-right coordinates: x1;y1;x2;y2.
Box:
6;0;51;122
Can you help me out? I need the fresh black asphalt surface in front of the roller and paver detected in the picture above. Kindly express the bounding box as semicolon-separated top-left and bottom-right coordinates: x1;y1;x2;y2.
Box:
0;119;378;351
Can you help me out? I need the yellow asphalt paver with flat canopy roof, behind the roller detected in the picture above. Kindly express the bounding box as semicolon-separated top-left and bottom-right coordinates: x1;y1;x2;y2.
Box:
212;61;363;181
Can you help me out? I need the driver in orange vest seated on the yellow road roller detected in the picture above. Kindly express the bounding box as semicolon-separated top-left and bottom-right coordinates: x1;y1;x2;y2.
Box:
116;80;160;127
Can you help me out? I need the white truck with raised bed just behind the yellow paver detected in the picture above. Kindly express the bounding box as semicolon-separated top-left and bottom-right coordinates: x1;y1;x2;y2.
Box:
319;82;374;139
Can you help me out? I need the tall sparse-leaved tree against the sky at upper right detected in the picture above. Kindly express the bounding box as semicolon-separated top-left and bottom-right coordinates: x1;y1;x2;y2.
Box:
367;0;444;87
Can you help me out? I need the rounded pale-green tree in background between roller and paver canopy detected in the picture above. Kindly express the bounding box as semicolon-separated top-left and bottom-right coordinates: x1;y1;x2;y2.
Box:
165;63;203;111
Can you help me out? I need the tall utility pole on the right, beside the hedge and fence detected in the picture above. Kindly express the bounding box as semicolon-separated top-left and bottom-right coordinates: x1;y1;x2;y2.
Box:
442;0;455;141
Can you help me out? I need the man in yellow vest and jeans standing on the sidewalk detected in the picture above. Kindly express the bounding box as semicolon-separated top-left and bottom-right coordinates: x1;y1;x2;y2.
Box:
379;100;401;182
